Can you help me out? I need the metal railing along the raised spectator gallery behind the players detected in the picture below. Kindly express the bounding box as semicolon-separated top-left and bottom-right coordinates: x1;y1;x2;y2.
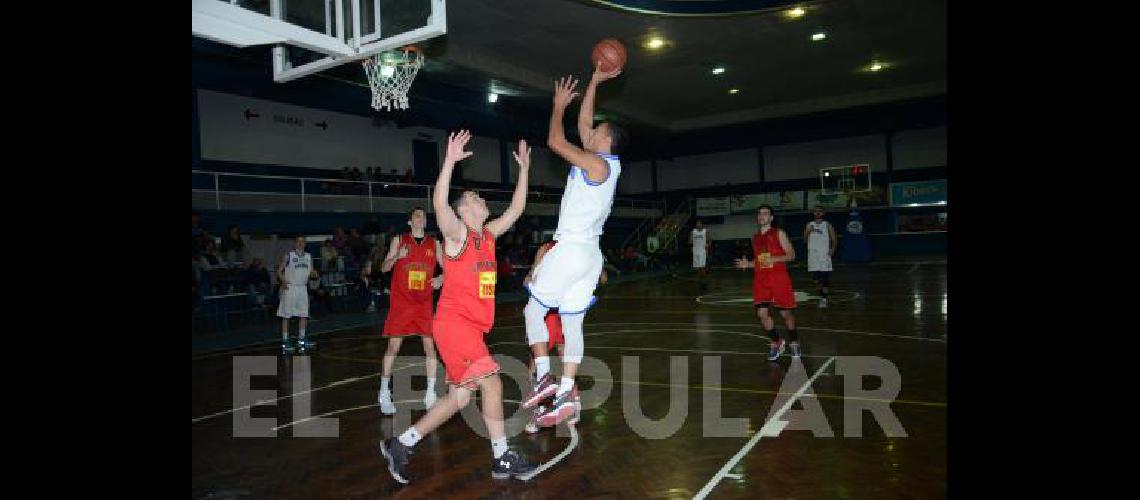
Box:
190;170;665;213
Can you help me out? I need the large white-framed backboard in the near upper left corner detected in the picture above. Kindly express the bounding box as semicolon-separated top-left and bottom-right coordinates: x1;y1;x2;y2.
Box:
192;0;447;83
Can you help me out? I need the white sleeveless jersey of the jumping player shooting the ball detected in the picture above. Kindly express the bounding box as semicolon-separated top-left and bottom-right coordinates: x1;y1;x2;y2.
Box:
554;154;621;241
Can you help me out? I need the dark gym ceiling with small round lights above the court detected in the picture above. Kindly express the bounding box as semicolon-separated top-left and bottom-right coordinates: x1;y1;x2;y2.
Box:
196;0;947;132
